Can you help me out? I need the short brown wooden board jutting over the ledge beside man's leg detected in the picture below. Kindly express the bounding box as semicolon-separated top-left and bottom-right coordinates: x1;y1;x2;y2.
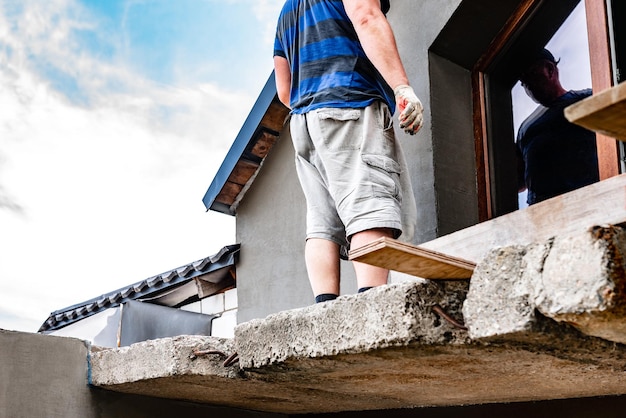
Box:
349;238;476;279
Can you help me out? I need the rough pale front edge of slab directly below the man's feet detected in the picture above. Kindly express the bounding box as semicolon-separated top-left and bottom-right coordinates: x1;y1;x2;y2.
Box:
235;281;468;369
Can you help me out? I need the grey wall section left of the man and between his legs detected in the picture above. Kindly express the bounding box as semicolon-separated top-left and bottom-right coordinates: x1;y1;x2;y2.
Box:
237;128;364;323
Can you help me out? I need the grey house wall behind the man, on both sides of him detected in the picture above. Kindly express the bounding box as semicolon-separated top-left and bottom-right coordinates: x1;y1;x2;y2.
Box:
237;0;460;323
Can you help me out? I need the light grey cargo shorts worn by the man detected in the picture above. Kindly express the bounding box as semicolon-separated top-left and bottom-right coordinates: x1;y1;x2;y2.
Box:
290;102;402;248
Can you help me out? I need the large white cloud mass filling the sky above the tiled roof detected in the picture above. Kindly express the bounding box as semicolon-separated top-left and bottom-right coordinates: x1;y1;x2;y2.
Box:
0;0;258;331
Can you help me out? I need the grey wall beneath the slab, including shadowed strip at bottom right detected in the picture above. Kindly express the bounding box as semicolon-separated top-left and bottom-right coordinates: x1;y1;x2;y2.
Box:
0;330;626;418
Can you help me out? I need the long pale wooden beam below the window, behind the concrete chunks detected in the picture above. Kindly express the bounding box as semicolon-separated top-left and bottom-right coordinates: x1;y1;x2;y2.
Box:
420;174;626;263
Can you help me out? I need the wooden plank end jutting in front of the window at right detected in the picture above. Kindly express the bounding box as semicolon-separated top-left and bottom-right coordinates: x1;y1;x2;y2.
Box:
565;82;626;141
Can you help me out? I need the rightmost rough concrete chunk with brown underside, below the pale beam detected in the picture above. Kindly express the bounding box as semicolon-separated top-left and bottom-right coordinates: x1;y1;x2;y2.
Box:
536;225;626;343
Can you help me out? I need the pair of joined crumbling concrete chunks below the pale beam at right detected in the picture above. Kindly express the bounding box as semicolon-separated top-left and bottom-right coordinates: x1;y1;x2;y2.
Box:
463;226;626;343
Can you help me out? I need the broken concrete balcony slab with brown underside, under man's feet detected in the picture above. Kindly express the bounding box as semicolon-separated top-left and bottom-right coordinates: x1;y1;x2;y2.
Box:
91;281;626;414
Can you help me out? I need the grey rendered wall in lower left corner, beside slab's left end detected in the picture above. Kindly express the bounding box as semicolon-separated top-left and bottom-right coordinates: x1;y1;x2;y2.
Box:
0;330;282;418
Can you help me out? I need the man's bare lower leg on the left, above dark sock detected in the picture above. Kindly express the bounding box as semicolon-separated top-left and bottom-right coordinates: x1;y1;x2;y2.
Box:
304;238;339;296
